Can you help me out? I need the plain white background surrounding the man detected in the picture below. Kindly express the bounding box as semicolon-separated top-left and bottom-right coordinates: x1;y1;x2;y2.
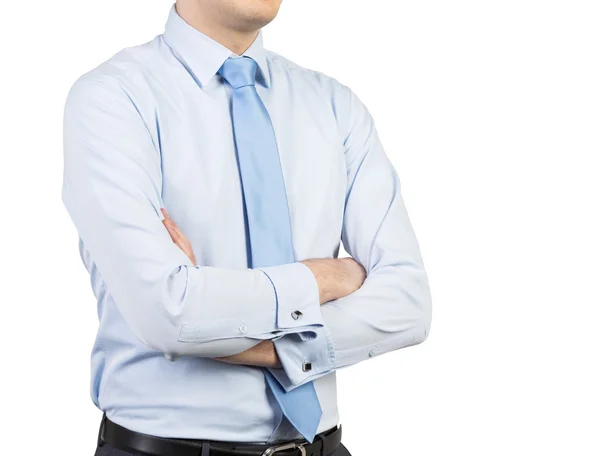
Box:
0;0;600;456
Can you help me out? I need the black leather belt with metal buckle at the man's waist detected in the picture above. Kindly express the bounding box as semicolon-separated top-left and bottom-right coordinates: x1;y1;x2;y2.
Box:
98;415;342;456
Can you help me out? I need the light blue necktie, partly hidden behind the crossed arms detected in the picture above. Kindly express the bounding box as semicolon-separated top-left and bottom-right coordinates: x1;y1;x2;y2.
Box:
219;57;322;443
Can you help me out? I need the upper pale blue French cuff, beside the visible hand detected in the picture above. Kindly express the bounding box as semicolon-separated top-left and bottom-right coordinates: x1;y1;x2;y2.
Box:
257;262;324;334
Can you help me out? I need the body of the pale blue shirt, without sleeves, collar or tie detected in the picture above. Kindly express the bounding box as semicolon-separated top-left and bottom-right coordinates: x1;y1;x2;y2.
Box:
81;26;348;442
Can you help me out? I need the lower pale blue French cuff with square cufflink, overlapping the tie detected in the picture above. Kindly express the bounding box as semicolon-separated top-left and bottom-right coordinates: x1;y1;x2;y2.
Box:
269;326;335;392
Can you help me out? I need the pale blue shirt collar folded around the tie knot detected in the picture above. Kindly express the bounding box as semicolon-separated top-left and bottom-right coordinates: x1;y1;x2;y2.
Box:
163;5;271;87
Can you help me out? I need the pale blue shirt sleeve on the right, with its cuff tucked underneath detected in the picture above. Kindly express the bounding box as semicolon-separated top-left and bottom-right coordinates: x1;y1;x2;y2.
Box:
271;84;431;391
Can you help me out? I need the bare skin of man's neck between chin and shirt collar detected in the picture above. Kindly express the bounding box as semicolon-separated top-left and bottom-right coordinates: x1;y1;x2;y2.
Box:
176;2;258;55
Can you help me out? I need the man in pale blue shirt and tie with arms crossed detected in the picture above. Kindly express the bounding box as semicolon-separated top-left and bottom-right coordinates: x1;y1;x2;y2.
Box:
63;0;431;456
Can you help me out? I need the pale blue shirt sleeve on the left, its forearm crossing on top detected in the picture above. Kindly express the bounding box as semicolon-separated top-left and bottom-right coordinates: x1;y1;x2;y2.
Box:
62;76;323;357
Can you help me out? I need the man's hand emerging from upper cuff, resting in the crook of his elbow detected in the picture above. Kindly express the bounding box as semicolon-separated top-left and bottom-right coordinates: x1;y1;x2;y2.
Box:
301;258;367;304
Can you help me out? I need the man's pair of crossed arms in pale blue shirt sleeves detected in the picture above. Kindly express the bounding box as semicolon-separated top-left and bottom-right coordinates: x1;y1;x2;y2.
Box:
63;79;431;390
